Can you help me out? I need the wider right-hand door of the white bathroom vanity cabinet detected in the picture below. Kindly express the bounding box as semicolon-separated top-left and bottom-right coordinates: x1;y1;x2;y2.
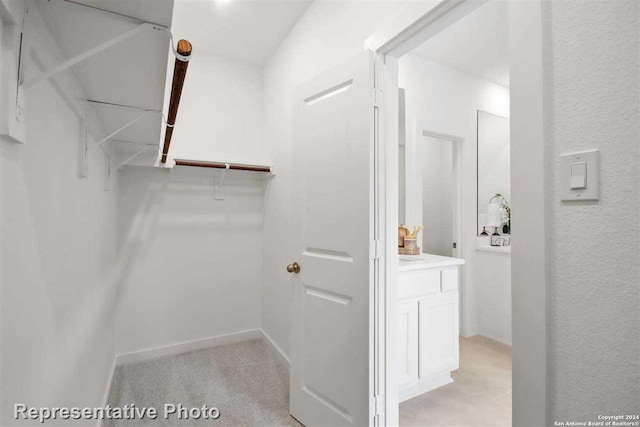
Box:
418;293;459;379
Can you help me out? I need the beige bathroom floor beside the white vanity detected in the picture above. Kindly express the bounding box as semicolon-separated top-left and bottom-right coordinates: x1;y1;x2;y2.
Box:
400;335;511;427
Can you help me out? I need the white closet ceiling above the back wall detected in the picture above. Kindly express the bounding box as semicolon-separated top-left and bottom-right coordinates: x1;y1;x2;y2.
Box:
172;0;312;65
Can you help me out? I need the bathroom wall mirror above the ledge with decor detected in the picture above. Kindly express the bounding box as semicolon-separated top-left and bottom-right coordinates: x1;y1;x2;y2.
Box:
478;110;511;235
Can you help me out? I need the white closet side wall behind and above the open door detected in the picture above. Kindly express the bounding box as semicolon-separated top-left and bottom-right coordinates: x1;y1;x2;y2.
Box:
262;1;416;362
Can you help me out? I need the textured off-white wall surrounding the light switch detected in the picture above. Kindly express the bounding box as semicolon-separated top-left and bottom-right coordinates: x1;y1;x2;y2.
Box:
545;0;640;421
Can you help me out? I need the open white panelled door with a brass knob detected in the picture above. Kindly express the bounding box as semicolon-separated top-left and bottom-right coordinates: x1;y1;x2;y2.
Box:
290;52;374;427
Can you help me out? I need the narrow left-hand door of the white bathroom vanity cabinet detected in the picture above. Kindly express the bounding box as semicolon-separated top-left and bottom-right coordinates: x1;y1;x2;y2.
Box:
397;301;418;386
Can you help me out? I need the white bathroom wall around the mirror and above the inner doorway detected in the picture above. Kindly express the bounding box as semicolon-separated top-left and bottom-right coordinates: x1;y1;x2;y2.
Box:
399;55;511;343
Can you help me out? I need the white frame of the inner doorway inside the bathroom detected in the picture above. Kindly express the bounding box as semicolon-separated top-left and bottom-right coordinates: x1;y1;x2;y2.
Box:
405;125;469;336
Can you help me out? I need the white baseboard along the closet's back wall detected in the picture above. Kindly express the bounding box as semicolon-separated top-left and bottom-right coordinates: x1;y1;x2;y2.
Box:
116;329;262;366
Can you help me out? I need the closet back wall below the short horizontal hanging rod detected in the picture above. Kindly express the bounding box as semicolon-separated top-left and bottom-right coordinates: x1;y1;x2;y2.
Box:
116;156;266;354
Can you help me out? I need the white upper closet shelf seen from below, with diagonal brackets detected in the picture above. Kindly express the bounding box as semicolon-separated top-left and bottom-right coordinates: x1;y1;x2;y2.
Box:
19;0;179;170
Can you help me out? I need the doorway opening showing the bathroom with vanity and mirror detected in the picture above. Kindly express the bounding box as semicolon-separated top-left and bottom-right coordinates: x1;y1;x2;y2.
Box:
384;0;512;426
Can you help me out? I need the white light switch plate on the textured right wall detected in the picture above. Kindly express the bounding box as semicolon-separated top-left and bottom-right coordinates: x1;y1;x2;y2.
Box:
558;150;600;201
